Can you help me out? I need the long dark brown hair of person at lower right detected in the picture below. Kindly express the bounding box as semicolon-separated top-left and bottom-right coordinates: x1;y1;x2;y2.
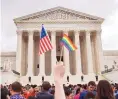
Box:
97;80;113;99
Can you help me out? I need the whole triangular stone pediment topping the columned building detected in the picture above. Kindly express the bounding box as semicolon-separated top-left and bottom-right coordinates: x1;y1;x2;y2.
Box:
14;7;103;22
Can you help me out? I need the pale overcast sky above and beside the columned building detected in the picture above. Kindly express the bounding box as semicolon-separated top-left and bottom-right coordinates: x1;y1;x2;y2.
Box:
0;0;118;52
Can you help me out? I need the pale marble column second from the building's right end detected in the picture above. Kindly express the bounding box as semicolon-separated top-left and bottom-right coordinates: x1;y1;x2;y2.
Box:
85;31;94;73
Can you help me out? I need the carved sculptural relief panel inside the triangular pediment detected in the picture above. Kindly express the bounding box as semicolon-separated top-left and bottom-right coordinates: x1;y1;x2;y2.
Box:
21;10;97;21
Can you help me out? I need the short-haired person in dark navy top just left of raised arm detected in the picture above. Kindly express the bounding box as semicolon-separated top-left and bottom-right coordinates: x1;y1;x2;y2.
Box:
36;81;54;99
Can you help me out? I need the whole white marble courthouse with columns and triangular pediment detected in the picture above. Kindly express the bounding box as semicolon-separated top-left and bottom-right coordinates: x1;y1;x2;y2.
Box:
14;7;104;84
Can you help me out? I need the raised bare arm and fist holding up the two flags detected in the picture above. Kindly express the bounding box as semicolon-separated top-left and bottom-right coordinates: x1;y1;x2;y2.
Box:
54;62;66;99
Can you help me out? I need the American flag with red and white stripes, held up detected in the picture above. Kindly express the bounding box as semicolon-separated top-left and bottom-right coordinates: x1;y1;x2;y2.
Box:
39;25;53;55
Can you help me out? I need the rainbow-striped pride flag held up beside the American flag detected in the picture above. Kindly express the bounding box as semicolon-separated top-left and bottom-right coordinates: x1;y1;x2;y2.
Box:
61;34;77;51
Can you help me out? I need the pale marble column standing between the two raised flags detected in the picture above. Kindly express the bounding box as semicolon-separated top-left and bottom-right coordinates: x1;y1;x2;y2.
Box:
51;31;56;75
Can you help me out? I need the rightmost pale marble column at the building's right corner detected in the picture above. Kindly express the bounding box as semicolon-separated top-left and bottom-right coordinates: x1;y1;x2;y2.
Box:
95;31;104;73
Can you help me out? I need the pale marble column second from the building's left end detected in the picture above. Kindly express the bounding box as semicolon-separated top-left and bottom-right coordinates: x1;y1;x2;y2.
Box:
27;31;34;76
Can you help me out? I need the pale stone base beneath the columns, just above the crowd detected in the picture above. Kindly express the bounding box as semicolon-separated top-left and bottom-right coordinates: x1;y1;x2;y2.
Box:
19;73;103;85
